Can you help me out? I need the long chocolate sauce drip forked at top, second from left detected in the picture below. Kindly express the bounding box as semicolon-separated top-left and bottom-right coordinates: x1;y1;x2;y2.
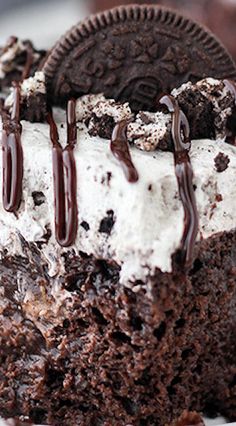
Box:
48;100;78;247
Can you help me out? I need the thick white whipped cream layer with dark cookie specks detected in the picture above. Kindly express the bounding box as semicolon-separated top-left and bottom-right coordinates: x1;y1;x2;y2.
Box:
0;100;236;285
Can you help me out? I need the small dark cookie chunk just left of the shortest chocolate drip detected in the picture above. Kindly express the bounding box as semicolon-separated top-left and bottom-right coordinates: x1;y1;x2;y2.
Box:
87;113;115;140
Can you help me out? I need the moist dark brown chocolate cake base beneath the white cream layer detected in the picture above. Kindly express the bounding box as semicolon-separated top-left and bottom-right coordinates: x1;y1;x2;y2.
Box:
0;232;236;426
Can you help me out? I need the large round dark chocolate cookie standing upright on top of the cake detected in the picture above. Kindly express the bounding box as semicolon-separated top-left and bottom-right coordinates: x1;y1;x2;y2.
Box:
44;5;236;111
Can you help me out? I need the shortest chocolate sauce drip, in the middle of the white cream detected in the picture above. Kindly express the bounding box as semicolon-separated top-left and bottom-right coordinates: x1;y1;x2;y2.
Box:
111;120;139;183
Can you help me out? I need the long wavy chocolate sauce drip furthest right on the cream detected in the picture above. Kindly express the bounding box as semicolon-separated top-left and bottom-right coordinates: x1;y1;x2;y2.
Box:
160;95;198;268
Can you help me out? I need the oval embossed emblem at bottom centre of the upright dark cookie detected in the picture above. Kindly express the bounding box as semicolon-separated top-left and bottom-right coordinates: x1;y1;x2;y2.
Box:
117;76;162;111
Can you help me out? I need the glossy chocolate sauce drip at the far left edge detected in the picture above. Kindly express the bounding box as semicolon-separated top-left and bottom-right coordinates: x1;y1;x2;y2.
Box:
1;83;23;213
